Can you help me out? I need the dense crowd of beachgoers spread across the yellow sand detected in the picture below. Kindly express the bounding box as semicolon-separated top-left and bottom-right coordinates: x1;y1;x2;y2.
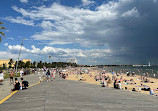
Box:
65;68;158;96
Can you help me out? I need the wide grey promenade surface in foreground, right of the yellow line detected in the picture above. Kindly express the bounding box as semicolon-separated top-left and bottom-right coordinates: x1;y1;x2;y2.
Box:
0;75;158;111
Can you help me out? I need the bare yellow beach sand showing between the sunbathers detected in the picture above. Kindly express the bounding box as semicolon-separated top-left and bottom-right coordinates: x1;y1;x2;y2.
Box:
66;70;158;95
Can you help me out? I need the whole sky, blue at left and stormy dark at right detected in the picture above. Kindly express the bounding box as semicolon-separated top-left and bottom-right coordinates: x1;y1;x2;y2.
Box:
0;0;158;65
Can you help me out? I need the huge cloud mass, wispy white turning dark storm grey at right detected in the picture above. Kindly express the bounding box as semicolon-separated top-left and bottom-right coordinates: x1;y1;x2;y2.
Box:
5;0;158;62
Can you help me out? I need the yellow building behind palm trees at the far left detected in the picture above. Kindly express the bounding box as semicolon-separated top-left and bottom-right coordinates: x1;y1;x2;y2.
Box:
0;59;31;67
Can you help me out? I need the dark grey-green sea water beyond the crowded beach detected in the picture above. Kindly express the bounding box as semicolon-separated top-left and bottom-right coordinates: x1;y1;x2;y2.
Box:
102;66;158;78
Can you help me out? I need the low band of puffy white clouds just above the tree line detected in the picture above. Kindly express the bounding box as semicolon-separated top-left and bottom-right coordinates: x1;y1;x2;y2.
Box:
5;44;112;63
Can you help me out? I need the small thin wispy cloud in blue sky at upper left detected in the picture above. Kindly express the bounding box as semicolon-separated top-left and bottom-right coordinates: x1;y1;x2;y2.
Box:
4;17;34;26
